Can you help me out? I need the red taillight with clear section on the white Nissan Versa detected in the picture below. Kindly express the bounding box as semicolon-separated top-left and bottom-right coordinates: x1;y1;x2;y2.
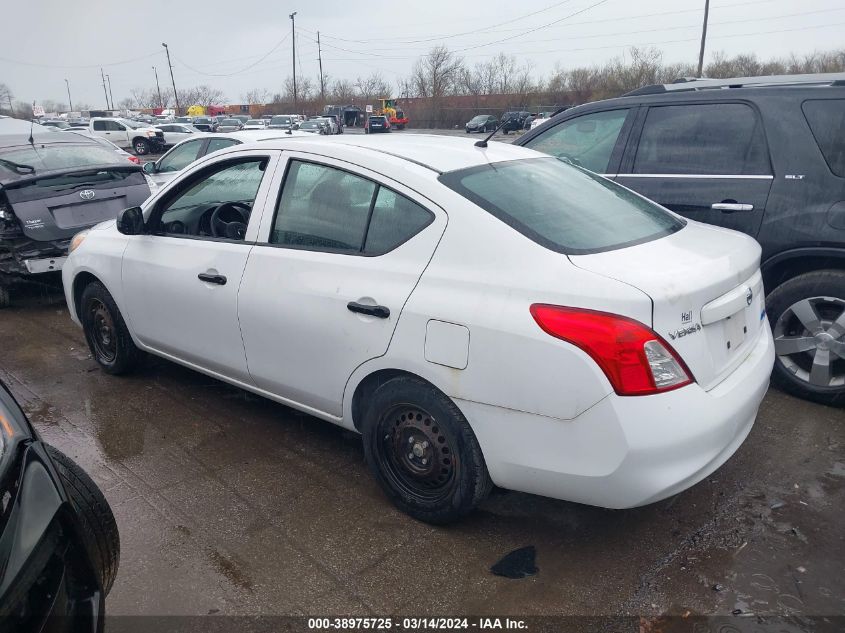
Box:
531;303;693;396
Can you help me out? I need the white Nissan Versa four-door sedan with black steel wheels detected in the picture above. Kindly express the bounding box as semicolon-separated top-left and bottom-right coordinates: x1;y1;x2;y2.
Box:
62;135;774;523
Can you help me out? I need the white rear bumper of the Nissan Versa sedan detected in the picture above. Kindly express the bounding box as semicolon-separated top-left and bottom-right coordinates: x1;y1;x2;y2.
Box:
458;326;774;508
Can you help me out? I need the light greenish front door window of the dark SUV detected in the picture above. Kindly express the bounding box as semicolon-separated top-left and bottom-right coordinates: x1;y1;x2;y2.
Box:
525;108;628;174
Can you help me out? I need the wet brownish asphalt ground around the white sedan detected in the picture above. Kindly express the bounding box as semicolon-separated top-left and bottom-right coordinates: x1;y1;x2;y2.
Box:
0;292;845;616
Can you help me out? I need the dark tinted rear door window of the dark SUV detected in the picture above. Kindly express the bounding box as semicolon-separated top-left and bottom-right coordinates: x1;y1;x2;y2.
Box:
633;103;771;176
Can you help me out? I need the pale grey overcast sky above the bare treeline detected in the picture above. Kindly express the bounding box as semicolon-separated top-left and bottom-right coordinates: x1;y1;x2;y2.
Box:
0;0;845;107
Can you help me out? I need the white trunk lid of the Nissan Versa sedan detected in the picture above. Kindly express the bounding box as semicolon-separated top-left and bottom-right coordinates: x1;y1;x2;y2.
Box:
569;221;765;390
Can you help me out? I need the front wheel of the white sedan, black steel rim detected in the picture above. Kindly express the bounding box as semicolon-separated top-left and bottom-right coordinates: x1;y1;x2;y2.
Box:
79;281;141;375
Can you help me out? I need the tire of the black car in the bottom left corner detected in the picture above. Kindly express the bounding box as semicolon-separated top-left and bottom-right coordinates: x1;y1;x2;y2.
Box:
45;445;120;595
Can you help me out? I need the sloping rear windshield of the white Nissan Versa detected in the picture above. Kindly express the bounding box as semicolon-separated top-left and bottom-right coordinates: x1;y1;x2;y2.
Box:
440;158;685;255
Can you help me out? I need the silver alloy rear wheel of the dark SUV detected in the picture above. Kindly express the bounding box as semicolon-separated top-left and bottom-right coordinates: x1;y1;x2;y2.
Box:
766;270;845;406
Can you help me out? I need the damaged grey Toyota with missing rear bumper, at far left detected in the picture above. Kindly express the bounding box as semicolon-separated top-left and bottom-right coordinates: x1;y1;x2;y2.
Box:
0;119;150;308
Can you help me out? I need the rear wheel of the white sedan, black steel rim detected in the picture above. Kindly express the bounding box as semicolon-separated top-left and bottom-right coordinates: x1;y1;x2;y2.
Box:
362;376;493;525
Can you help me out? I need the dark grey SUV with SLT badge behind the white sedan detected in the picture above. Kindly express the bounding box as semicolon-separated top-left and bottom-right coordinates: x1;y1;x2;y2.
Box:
516;73;845;404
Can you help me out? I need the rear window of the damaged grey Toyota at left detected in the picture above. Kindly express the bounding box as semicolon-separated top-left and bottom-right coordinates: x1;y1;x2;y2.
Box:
0;142;125;182
